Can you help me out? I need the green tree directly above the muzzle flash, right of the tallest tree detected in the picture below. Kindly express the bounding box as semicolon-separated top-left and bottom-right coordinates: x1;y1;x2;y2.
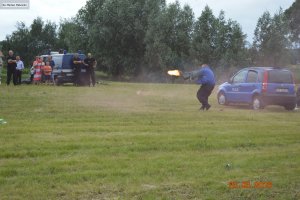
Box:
145;2;194;71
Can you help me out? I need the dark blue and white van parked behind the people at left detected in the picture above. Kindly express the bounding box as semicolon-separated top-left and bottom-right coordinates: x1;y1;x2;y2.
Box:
42;53;88;85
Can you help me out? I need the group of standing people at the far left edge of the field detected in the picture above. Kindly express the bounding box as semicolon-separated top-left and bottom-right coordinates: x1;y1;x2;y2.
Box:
0;50;25;85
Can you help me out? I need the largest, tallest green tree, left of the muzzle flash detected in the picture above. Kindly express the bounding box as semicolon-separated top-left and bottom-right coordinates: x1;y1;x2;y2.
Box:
78;0;165;76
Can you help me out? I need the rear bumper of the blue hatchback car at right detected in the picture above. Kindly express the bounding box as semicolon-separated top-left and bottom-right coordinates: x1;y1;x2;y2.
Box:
262;94;297;105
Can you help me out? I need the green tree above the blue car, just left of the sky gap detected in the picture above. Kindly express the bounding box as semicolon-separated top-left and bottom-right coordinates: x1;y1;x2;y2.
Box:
193;6;247;67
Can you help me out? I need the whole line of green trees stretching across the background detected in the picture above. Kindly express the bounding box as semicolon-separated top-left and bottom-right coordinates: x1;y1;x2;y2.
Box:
0;0;300;77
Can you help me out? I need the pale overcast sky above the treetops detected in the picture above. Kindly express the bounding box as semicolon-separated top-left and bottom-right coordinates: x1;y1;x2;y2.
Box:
0;0;295;42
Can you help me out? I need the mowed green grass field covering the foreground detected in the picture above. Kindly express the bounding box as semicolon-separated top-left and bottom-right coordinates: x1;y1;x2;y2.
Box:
0;82;300;200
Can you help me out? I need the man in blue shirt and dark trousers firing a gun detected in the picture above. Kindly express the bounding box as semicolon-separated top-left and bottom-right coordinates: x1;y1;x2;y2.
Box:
197;64;215;110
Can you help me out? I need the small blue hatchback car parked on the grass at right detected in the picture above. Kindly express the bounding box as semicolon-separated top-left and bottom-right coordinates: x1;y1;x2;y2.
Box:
218;67;297;110
